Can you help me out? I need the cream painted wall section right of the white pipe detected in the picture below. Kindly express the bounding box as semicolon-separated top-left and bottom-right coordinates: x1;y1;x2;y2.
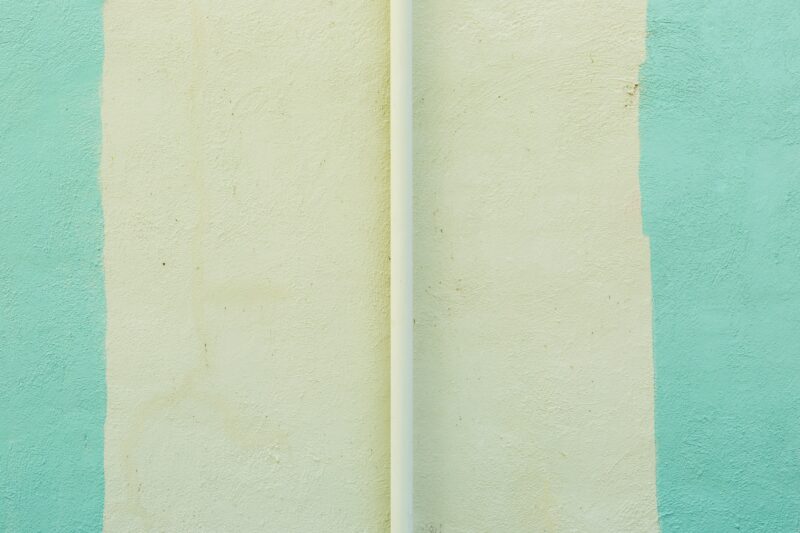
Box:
414;0;658;532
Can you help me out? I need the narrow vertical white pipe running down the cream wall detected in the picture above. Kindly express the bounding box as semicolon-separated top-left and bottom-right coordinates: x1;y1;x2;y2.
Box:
389;0;414;533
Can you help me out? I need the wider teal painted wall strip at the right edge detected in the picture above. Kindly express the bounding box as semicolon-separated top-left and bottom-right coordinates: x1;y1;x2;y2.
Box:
640;0;800;533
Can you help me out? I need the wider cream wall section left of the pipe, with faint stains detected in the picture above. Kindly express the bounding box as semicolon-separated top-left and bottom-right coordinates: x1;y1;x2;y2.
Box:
102;0;389;532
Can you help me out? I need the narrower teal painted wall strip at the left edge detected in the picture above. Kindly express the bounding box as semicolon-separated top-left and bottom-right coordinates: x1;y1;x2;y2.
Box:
0;0;106;532
